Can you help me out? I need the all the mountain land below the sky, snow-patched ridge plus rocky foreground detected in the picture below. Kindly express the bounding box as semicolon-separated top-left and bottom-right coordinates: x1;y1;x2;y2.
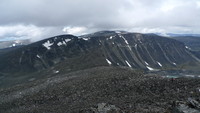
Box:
0;31;200;113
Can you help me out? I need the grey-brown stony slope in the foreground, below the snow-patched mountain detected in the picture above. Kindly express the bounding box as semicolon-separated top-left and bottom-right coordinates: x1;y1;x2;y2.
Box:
0;67;200;113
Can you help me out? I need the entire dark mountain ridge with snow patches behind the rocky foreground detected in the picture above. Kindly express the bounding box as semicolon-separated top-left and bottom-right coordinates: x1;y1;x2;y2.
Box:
0;31;199;86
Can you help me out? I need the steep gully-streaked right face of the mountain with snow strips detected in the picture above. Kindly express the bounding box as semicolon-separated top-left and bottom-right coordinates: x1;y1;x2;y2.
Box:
89;32;198;70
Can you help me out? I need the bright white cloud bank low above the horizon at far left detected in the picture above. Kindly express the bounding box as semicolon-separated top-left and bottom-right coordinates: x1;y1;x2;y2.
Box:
0;25;62;41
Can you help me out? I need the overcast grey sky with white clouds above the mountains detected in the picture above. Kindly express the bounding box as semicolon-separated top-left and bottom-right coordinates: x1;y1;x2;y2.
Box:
0;0;200;41
